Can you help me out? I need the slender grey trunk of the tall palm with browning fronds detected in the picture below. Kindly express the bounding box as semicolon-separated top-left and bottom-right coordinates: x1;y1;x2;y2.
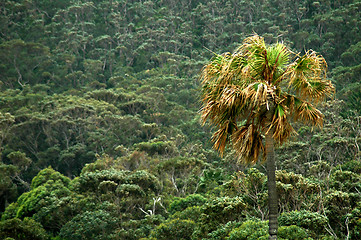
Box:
266;131;278;240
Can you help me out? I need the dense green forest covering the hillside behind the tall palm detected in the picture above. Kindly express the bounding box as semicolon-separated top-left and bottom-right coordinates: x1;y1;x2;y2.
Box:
0;0;361;240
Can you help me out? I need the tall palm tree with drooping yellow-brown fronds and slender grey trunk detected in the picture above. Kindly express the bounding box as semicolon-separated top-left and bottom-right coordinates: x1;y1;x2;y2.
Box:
201;35;334;239
